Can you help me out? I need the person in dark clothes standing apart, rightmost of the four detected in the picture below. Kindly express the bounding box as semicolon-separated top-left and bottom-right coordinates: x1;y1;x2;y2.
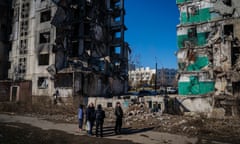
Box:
114;102;123;134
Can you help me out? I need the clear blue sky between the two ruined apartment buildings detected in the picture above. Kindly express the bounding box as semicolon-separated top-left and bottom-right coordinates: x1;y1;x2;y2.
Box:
125;0;179;68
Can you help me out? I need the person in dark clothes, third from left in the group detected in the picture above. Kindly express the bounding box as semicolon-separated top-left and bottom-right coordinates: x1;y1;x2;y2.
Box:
95;104;105;137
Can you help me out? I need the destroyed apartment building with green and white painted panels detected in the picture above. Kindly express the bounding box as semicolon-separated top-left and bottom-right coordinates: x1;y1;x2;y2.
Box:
177;0;240;115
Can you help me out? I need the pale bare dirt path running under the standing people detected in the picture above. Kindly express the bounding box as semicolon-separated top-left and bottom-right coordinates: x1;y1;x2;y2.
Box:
0;114;232;144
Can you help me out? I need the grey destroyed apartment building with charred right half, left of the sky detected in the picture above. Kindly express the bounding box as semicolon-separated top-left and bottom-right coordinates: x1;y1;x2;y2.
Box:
2;0;130;103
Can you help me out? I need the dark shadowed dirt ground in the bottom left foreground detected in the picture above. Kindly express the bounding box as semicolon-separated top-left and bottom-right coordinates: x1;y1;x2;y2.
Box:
0;123;137;144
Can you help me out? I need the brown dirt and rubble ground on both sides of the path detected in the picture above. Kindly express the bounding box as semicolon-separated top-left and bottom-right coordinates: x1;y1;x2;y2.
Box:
0;103;240;144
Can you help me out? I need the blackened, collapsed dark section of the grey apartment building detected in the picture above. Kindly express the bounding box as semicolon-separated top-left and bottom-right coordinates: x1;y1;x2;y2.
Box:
51;0;129;99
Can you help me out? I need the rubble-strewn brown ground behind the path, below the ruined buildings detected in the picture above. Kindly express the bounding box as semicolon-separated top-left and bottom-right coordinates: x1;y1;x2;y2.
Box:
0;104;240;143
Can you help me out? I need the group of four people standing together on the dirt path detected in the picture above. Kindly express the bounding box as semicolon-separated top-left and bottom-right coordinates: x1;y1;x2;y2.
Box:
78;102;123;137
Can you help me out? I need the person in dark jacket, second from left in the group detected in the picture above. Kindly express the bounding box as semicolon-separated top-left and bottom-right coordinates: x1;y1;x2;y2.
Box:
86;103;95;136
